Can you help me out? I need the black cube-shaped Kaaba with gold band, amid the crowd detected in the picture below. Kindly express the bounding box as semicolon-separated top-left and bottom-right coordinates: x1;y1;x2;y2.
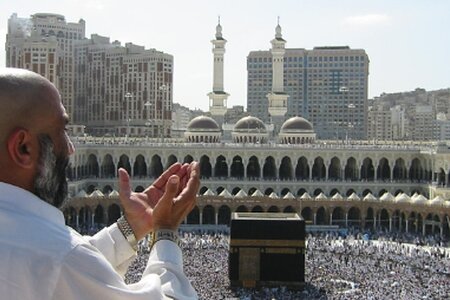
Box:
228;212;305;289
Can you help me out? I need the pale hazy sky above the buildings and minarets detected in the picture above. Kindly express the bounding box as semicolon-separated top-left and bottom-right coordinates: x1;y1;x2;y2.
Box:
0;0;450;110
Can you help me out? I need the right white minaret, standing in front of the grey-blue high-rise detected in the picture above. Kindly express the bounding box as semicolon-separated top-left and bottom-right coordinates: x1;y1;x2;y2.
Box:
267;19;289;134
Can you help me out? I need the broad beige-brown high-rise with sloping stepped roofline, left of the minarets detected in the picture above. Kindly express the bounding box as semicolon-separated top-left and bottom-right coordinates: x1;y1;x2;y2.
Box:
74;35;173;138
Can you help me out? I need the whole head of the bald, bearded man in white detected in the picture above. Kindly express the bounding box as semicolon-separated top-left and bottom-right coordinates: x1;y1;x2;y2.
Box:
0;68;73;199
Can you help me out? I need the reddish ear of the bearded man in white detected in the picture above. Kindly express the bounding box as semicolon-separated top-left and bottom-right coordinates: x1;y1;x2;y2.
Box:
6;128;34;169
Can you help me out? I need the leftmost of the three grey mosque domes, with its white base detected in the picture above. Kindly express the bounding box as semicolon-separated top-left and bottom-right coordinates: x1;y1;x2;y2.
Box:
184;116;221;143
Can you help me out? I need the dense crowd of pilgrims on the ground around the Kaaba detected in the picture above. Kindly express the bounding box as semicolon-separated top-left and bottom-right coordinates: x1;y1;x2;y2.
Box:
121;230;450;300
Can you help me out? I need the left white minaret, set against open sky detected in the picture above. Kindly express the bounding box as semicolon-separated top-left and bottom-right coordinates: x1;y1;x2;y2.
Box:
208;17;229;127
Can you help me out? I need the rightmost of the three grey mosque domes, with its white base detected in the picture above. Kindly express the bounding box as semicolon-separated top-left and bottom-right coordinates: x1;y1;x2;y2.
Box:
278;117;316;144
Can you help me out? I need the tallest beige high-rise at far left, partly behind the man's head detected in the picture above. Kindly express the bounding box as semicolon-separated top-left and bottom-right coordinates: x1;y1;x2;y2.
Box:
6;13;85;118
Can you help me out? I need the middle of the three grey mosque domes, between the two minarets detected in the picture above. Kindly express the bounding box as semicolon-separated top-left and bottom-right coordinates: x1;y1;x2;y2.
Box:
232;116;269;144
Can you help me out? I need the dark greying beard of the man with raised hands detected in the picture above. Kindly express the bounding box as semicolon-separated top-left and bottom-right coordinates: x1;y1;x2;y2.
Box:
34;135;69;207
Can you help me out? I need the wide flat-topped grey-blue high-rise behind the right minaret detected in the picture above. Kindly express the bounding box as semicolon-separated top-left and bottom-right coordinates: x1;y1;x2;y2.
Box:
247;40;369;139
